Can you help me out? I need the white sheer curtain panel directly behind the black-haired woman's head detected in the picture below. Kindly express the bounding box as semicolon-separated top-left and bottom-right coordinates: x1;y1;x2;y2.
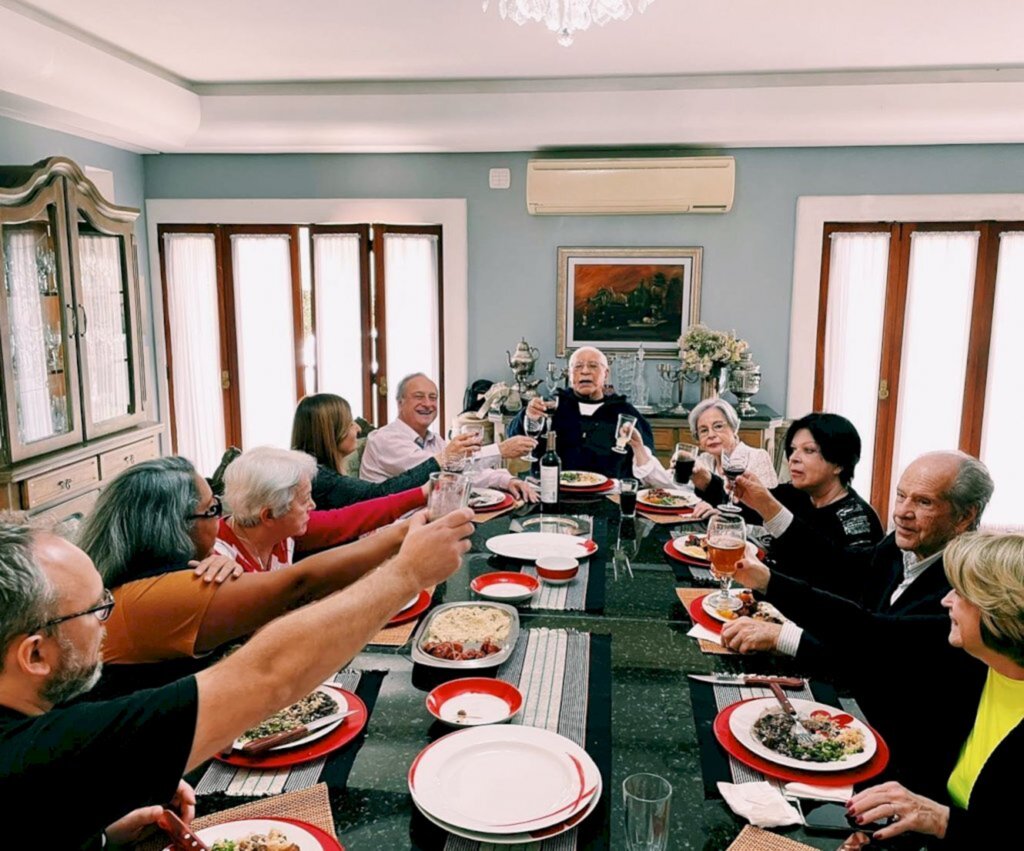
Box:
823;232;890;500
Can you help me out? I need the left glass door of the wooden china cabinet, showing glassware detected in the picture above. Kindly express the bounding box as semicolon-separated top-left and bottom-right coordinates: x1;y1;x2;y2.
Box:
0;180;83;462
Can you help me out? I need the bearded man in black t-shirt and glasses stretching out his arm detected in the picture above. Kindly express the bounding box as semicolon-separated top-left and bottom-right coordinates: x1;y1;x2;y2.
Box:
0;509;473;849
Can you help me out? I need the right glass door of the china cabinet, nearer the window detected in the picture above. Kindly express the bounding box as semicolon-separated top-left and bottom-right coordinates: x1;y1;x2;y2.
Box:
68;188;143;438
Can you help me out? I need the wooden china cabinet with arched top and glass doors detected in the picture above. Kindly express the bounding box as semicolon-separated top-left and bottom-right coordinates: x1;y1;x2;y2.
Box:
0;157;161;519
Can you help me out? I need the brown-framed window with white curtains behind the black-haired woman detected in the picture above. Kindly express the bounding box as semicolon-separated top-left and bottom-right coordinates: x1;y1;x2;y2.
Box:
814;222;1024;524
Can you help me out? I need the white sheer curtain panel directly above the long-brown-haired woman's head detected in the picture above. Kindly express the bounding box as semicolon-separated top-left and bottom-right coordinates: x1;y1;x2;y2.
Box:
313;233;364;419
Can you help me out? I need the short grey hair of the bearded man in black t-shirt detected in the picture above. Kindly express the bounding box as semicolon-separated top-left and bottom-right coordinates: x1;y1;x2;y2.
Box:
0;520;58;671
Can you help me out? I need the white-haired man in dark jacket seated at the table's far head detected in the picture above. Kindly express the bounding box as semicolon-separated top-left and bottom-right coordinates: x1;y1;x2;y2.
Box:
509;346;654;476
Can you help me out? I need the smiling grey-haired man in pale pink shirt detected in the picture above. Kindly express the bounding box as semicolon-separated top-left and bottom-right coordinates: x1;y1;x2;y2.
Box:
359;373;537;502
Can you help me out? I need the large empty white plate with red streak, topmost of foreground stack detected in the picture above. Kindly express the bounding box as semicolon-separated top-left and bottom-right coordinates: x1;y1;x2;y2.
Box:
409;725;600;834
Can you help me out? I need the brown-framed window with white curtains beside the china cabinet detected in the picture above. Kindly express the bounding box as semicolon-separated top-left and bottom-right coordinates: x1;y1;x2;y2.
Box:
159;224;443;473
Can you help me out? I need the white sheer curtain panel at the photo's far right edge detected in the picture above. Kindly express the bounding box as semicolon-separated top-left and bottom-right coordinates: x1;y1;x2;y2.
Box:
981;231;1024;528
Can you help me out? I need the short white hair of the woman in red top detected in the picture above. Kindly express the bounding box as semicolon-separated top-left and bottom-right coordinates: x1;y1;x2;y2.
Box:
224;446;316;527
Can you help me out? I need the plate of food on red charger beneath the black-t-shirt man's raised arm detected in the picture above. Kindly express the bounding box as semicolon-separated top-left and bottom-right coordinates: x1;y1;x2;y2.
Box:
215;683;370;768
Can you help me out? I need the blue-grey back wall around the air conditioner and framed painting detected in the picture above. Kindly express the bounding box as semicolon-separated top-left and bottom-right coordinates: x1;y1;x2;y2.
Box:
144;145;1024;411
